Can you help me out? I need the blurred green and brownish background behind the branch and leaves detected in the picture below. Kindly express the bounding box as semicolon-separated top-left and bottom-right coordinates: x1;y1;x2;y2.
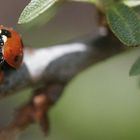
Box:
0;0;140;140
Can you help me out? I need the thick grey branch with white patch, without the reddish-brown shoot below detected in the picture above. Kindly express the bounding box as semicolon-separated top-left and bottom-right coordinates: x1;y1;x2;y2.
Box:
0;34;124;97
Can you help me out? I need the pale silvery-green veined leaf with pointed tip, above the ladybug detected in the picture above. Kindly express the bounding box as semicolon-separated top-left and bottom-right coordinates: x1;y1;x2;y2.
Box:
18;0;62;24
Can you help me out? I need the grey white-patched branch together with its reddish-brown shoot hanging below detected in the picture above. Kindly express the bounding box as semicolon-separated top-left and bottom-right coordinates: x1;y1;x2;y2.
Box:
0;30;125;140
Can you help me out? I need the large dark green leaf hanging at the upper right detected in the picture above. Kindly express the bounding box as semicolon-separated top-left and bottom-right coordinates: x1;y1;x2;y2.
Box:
107;3;140;46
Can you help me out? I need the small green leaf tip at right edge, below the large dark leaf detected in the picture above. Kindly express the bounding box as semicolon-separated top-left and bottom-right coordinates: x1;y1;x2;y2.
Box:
129;57;140;76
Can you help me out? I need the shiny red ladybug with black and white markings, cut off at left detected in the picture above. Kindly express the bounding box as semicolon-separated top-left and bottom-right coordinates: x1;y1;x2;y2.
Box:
0;26;23;69
